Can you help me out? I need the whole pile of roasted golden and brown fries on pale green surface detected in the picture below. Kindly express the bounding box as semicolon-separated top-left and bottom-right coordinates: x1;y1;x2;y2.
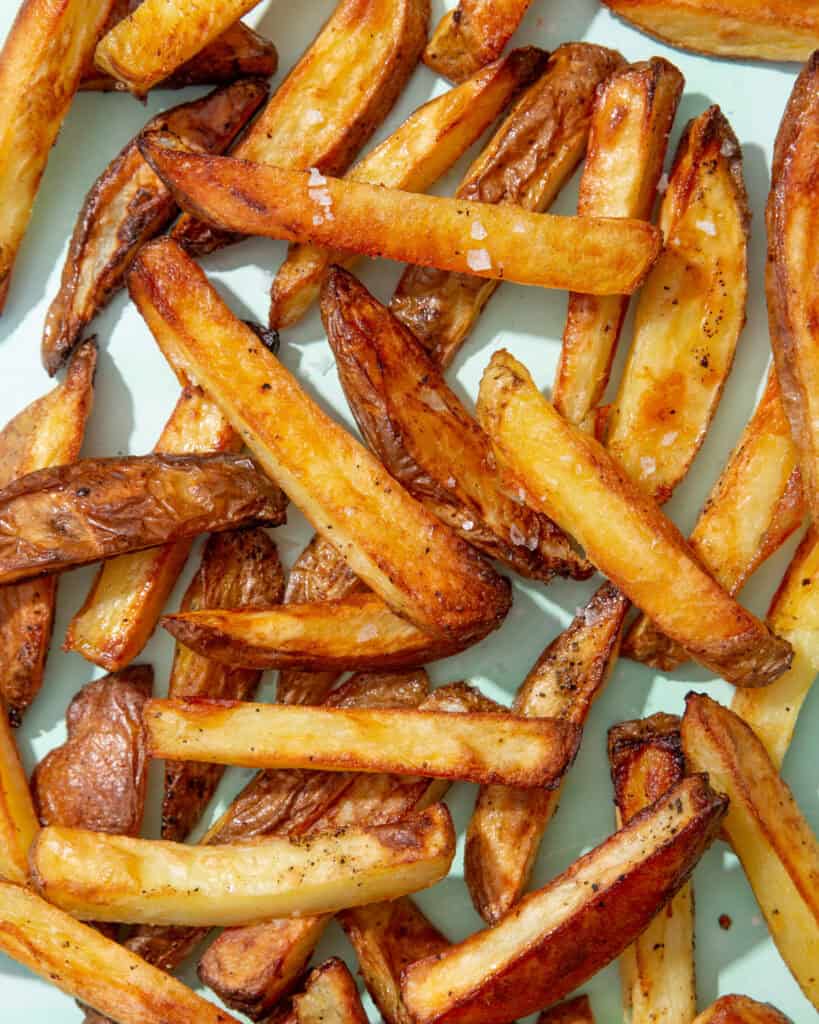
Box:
0;0;819;1024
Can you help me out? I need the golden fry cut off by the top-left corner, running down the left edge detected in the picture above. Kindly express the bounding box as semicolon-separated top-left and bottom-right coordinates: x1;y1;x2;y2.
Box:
0;0;114;312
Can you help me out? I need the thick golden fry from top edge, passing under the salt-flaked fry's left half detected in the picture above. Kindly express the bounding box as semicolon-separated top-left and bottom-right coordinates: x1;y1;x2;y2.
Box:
173;0;429;255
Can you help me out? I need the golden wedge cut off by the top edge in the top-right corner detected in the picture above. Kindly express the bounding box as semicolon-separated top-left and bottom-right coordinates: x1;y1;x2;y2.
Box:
603;0;819;61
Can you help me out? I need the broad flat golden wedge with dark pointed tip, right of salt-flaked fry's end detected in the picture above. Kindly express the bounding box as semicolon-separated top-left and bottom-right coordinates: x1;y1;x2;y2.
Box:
606;106;750;502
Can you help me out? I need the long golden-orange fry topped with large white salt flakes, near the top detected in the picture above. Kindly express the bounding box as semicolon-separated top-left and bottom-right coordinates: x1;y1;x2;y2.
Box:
139;132;659;295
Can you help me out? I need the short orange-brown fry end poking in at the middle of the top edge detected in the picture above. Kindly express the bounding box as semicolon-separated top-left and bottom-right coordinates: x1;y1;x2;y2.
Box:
424;0;531;82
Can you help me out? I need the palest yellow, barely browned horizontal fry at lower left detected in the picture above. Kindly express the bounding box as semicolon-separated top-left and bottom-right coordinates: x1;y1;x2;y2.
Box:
31;804;455;927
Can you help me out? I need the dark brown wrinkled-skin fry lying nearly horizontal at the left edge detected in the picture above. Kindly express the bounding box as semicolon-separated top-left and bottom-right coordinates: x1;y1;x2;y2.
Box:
0;455;285;583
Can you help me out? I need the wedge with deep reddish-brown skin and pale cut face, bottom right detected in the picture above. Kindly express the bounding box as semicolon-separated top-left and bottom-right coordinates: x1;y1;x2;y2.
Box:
401;775;727;1024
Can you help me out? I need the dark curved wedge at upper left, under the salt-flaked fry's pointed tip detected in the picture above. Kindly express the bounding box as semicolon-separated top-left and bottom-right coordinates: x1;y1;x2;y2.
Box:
42;79;267;376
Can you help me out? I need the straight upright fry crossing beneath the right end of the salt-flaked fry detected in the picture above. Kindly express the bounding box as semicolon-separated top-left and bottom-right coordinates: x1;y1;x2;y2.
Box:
552;57;684;426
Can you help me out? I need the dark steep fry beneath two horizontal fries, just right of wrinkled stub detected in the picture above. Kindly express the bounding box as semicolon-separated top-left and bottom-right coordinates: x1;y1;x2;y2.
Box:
162;529;285;843
